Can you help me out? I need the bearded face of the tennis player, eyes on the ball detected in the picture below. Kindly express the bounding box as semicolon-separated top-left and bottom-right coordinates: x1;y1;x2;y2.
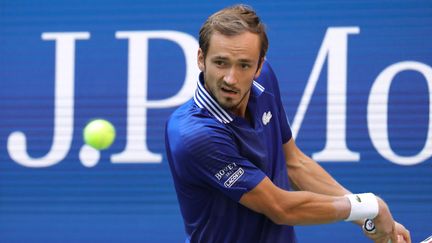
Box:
198;31;261;116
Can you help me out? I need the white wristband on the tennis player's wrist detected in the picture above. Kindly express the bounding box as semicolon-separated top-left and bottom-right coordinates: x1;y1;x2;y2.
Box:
345;193;378;221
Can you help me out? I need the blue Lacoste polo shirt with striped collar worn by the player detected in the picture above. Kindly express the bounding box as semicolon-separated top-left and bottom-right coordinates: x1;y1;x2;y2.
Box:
165;62;296;243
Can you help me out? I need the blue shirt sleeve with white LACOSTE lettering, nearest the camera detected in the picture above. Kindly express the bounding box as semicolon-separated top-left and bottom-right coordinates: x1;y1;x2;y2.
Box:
176;119;266;201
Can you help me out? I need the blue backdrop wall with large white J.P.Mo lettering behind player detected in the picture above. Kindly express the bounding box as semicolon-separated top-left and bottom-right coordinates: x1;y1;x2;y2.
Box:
0;0;432;242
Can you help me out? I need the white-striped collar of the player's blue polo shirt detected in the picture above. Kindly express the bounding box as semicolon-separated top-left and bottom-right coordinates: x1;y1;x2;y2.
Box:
194;73;265;124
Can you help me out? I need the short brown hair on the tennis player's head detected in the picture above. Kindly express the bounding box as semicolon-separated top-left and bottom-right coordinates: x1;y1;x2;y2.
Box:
199;4;268;64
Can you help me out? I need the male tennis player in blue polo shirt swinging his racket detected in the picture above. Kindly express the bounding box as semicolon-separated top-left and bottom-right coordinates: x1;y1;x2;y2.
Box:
165;5;411;243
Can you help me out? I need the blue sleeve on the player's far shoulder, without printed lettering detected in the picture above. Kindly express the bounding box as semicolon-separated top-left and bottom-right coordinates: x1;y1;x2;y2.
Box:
257;60;292;144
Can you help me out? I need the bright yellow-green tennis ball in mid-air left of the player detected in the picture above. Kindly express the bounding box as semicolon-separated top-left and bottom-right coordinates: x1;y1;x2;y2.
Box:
83;119;115;150
